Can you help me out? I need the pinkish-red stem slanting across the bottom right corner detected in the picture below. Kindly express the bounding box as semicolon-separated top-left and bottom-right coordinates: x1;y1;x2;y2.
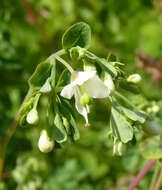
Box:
127;160;156;190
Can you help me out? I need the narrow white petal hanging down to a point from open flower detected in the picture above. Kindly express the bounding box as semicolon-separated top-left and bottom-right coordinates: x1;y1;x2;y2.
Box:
74;87;88;123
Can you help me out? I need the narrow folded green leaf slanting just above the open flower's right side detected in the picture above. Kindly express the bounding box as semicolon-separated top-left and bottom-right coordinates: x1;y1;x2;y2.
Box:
96;58;118;78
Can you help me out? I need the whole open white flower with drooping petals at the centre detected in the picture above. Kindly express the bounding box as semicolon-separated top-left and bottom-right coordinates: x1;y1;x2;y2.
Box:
61;71;110;123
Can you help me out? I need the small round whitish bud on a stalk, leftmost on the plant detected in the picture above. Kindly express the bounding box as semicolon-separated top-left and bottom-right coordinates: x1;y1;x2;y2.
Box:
26;108;39;125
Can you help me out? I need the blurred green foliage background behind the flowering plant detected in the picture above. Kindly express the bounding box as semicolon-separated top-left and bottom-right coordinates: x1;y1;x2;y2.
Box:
0;0;162;190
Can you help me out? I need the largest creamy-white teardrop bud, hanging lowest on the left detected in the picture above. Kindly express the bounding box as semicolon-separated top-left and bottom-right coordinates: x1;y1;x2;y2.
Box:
38;130;54;153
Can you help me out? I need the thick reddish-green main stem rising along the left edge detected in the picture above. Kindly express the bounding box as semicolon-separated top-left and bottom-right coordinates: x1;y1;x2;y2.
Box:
0;89;33;181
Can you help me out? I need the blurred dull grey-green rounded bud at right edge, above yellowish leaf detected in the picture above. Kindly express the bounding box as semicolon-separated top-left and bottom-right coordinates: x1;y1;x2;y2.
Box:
142;121;160;136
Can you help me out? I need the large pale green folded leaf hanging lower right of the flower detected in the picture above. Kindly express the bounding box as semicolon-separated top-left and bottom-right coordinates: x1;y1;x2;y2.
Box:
110;104;133;143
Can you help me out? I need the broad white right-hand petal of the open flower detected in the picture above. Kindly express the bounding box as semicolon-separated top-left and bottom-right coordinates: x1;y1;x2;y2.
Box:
83;75;110;98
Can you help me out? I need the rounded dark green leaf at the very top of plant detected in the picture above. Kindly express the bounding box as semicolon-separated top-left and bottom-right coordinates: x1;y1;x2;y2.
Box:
62;22;91;50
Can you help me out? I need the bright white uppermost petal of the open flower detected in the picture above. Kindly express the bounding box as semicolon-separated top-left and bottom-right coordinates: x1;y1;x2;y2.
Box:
72;71;96;86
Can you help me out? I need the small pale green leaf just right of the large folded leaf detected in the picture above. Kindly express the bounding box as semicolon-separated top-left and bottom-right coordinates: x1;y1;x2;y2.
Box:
122;107;147;124
